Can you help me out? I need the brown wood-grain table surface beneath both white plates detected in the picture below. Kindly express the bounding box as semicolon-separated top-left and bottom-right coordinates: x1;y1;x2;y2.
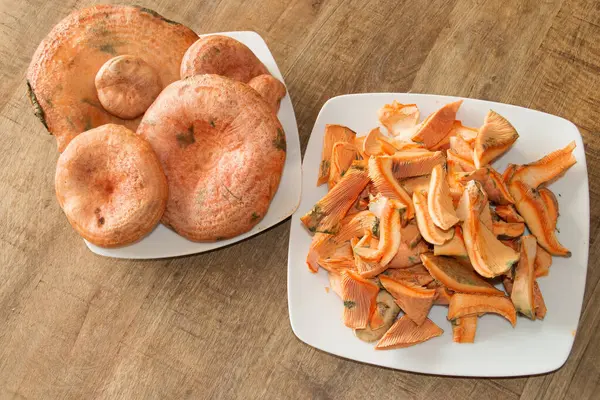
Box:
0;0;600;400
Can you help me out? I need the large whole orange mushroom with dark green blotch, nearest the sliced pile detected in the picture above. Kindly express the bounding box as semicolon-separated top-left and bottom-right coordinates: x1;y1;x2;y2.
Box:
137;75;288;241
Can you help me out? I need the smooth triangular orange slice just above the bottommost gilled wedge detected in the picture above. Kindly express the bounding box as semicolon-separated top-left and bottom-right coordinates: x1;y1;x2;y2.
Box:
379;275;435;325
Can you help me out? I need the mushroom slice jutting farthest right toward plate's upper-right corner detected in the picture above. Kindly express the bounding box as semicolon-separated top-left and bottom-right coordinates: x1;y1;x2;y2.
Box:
510;142;577;189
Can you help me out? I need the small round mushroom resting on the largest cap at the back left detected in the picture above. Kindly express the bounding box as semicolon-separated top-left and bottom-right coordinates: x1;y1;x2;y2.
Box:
96;55;162;119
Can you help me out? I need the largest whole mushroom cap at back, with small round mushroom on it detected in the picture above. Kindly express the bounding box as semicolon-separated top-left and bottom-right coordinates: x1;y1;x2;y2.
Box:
27;5;198;152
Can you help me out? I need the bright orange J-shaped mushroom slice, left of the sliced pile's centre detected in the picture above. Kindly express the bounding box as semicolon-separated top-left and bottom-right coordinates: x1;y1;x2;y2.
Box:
354;199;404;268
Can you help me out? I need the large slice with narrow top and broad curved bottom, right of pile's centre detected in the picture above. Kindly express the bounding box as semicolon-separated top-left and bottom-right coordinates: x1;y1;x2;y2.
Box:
459;181;519;278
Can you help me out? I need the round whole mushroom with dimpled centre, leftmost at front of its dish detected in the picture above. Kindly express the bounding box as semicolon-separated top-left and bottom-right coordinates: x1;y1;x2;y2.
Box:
55;124;168;247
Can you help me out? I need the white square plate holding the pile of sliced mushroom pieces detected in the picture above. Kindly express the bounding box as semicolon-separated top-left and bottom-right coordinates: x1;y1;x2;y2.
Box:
288;93;589;377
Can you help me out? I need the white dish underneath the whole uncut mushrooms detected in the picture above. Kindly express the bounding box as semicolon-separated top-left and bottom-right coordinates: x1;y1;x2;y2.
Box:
86;32;302;258
